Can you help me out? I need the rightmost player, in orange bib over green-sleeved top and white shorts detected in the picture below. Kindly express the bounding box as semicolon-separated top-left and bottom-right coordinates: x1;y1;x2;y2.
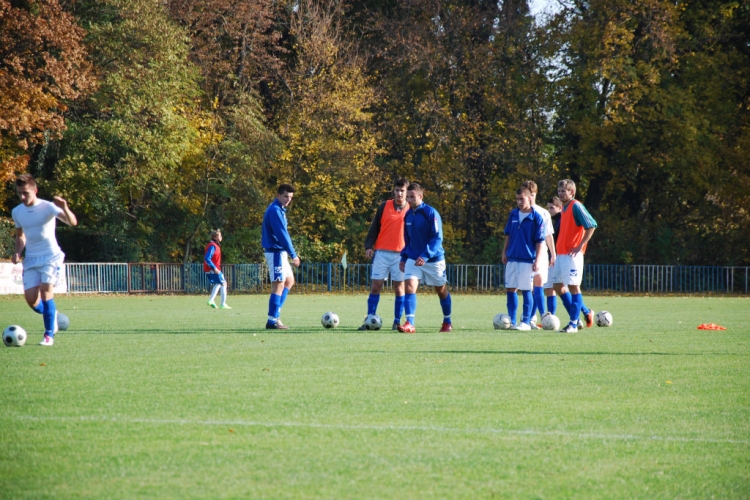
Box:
552;179;597;333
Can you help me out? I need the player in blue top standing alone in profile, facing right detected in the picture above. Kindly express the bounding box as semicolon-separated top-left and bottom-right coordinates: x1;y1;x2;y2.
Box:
261;184;300;330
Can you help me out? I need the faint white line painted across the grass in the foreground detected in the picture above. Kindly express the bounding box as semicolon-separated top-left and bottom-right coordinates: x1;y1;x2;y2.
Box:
15;415;750;444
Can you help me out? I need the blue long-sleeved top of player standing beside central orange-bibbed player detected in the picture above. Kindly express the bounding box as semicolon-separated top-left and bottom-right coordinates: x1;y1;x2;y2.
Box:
401;203;445;262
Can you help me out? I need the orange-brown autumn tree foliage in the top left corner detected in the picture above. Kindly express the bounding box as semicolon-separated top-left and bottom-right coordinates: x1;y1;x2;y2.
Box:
0;0;95;195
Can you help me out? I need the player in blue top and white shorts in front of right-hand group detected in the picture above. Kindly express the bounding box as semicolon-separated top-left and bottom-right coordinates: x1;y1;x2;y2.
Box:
503;187;547;330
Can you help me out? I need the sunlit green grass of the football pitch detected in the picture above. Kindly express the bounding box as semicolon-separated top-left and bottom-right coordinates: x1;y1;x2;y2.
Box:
0;293;750;499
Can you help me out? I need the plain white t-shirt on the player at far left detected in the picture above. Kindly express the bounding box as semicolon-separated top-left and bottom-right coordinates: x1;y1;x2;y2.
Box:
12;198;63;261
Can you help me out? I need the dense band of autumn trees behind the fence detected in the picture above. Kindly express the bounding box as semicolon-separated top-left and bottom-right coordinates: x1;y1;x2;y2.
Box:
0;0;750;265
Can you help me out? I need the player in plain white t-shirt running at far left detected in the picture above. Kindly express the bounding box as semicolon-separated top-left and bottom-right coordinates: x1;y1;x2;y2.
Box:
11;174;78;346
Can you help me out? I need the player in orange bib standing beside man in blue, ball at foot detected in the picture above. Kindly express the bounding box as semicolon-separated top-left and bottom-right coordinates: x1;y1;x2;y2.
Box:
358;177;409;330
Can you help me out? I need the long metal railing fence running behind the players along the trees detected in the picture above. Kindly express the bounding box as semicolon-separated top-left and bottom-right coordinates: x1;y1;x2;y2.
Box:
65;263;750;295
